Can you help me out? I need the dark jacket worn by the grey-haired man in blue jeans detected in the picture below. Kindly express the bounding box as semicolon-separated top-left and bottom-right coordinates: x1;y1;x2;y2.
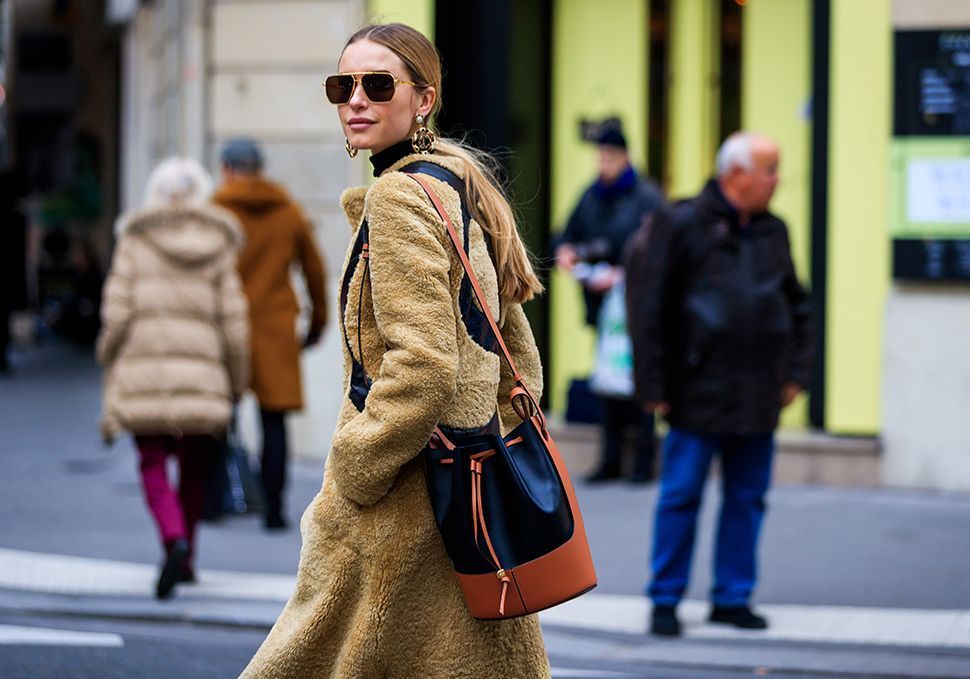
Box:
627;180;812;434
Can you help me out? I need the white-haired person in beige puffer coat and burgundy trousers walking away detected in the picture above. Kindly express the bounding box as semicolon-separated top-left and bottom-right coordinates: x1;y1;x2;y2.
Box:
97;158;249;598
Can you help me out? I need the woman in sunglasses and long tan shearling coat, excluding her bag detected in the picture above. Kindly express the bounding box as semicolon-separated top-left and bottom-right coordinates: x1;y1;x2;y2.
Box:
243;24;549;679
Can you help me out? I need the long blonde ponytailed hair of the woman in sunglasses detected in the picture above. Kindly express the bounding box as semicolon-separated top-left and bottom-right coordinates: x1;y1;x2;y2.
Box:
344;24;542;304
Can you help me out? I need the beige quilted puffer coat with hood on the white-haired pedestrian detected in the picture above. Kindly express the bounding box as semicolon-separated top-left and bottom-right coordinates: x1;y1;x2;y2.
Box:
97;206;249;439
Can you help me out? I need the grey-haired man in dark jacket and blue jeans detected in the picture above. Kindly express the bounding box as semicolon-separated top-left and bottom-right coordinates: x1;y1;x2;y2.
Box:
627;132;812;636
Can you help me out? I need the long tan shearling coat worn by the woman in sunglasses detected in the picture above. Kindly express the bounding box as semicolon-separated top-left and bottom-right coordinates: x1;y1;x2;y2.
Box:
242;155;550;679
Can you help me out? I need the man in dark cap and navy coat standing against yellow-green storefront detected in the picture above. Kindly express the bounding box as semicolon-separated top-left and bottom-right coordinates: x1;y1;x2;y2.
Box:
556;118;664;483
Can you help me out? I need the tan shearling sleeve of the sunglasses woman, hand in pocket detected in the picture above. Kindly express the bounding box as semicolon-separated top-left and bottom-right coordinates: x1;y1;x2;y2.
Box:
329;178;458;505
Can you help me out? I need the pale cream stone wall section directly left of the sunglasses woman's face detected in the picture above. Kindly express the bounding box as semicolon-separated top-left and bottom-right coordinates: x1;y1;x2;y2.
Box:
206;0;367;457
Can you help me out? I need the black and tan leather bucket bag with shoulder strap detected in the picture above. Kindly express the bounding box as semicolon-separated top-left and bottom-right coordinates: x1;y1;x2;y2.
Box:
408;173;596;620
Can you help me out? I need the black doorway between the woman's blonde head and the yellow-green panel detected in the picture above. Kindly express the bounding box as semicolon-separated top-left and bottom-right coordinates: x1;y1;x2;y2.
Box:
435;0;552;398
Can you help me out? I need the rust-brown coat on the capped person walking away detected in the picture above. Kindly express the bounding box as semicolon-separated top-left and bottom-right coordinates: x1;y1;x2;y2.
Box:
213;175;327;411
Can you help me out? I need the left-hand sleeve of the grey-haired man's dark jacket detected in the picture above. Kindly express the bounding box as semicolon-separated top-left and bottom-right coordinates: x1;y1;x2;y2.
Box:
626;210;684;404
